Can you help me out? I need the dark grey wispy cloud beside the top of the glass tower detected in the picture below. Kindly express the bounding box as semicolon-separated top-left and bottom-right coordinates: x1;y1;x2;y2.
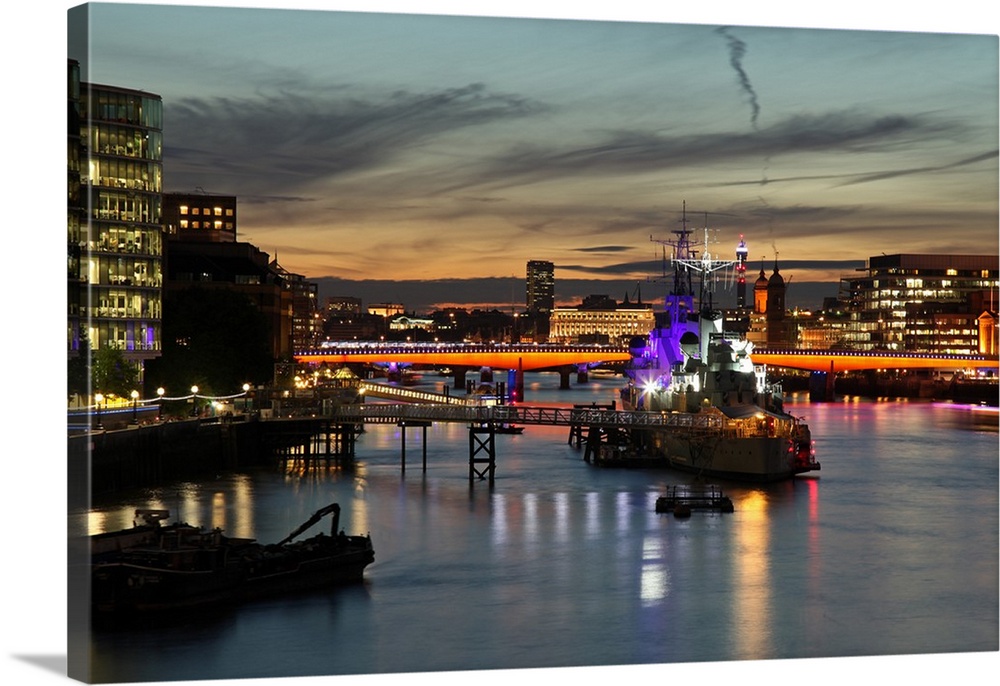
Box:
164;83;543;197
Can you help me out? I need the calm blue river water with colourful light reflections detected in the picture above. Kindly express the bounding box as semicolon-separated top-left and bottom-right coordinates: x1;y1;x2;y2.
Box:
70;374;998;682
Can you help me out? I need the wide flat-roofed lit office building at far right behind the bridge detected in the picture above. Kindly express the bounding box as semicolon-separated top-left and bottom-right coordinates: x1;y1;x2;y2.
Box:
840;254;1000;354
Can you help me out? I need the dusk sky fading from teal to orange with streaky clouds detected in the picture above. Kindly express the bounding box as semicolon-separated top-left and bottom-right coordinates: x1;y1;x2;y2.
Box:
64;3;998;310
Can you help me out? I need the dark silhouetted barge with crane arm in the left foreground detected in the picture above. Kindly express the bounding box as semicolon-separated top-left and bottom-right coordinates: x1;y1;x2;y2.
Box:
90;503;375;615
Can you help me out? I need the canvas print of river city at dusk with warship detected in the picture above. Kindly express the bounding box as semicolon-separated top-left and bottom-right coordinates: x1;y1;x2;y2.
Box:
66;2;1000;683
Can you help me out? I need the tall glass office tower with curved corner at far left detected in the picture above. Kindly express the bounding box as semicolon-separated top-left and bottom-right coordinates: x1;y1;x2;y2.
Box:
68;60;163;378
